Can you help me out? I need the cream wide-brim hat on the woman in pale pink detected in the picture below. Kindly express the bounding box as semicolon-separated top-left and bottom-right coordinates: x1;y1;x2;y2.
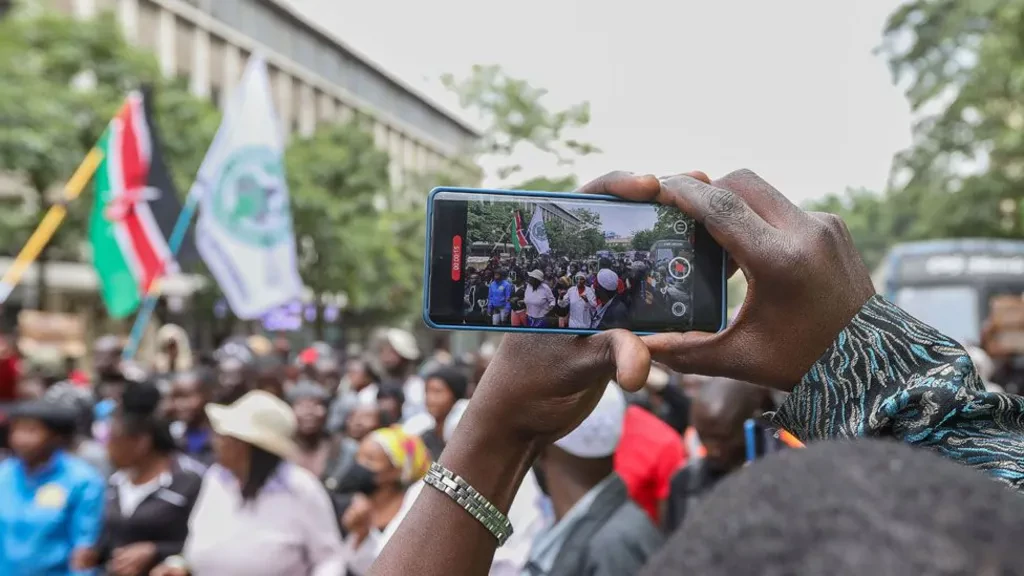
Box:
206;390;298;459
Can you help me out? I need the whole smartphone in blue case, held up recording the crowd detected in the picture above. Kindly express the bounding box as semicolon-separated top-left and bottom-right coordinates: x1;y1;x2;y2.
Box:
423;188;726;334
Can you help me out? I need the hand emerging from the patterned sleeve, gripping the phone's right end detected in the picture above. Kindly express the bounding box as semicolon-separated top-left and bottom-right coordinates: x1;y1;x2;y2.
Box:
583;170;874;392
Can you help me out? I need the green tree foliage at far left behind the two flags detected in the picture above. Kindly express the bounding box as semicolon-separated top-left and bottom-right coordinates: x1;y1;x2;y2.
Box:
0;8;219;259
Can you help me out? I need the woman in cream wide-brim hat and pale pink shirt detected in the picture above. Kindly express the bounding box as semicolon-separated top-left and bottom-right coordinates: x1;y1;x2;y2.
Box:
153;390;346;576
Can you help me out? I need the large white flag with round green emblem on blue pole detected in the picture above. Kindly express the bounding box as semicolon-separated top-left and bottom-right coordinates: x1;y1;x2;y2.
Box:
194;55;302;320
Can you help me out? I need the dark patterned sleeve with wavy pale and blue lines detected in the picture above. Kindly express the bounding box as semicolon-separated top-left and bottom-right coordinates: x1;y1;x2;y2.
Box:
775;296;1024;489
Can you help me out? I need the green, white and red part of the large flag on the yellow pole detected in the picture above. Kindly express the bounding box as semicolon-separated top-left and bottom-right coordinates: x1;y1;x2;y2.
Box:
89;92;196;318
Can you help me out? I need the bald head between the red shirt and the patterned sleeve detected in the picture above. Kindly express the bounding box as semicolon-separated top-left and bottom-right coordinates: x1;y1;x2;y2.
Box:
691;378;765;471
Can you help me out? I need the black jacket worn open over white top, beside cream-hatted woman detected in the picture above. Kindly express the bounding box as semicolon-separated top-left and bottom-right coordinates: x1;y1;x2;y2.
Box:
97;456;203;574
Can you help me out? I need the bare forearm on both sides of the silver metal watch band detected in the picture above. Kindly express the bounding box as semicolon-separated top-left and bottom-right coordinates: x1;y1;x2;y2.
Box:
371;411;537;576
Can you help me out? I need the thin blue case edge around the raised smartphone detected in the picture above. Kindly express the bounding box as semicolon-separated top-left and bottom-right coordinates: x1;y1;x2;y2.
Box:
423;187;729;336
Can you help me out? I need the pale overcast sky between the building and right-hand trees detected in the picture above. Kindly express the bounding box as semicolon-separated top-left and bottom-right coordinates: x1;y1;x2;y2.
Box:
291;0;910;202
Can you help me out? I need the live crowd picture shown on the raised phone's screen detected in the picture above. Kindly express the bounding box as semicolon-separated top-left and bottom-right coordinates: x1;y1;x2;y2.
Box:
461;196;694;330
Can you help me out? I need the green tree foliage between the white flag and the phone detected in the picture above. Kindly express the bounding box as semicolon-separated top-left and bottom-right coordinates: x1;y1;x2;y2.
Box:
285;123;424;323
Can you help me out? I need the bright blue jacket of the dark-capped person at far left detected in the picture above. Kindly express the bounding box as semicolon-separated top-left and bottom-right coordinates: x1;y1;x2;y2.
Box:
0;452;105;576
